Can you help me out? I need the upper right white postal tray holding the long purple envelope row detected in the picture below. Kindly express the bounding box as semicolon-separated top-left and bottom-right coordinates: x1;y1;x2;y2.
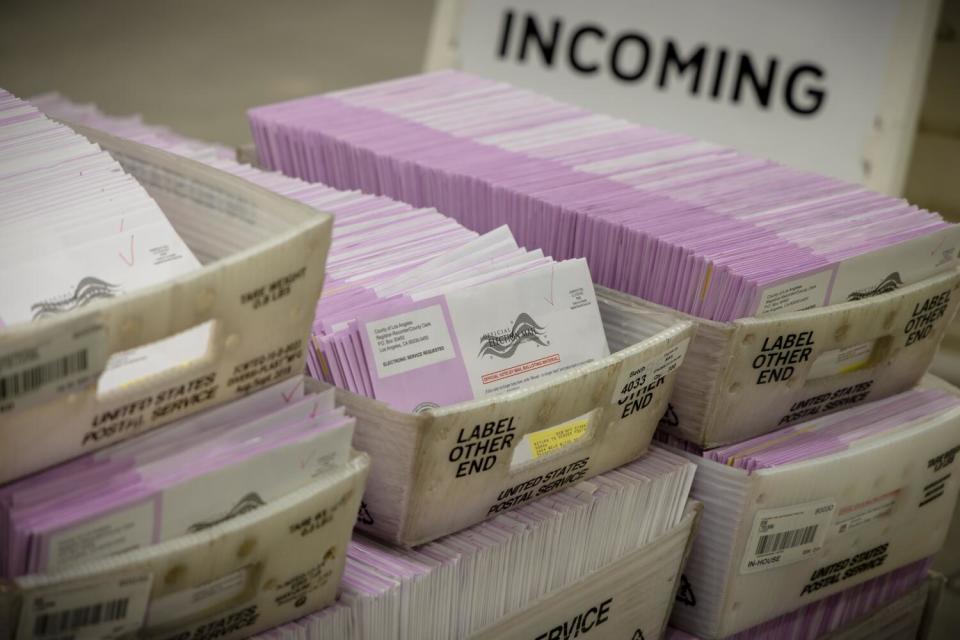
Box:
597;271;960;449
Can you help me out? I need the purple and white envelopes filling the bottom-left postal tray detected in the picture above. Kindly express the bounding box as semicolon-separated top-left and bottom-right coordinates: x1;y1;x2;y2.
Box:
0;377;354;577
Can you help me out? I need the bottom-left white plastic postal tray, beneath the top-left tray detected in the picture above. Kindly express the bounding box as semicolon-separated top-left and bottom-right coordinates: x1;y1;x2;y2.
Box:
0;453;370;640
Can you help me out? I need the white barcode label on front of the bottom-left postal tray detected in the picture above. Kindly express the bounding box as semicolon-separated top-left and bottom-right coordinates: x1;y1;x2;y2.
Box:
16;574;153;640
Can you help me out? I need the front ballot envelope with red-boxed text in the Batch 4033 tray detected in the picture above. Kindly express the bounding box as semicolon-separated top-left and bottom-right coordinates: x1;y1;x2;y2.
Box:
357;260;609;411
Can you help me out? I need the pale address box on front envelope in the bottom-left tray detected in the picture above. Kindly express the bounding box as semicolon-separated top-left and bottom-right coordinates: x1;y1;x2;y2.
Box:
44;500;154;573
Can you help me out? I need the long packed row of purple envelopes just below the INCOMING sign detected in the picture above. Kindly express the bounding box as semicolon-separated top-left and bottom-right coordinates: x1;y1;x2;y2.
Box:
249;71;960;322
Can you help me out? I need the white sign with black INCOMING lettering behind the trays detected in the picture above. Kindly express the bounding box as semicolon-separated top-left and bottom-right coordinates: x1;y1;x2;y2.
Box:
446;0;909;182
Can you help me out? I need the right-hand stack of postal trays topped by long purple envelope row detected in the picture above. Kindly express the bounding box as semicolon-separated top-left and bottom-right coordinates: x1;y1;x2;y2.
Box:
249;72;960;639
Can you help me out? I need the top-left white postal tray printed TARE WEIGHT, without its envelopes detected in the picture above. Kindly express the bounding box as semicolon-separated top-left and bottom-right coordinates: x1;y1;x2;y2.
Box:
0;127;332;484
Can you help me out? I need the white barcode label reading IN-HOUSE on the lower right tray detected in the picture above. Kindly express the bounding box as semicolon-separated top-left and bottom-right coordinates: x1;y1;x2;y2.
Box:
740;499;836;573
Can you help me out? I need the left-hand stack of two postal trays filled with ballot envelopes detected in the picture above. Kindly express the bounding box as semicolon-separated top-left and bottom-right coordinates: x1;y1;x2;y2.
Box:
0;94;369;638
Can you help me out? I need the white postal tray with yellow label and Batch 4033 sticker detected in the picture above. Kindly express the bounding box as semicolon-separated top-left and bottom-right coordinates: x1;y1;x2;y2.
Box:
337;318;693;546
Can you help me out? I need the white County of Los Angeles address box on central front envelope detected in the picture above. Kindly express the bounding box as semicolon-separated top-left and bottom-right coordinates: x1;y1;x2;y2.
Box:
366;305;456;378
